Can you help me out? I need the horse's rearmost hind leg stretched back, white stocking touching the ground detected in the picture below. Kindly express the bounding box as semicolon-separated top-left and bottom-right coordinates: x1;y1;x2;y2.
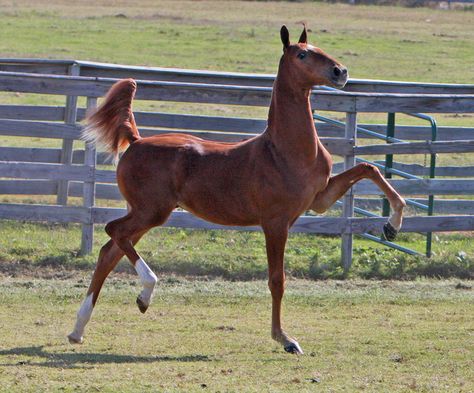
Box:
68;230;147;344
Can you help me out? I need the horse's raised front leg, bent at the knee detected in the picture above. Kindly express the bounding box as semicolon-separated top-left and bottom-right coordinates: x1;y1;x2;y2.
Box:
311;163;406;241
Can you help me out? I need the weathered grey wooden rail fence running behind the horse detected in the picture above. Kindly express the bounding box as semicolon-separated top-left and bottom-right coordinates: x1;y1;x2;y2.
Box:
0;59;474;268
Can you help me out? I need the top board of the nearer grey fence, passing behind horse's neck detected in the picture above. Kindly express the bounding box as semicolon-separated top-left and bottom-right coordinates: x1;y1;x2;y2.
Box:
0;72;474;113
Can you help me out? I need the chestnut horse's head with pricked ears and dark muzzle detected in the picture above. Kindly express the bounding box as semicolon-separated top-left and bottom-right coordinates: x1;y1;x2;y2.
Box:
280;25;349;89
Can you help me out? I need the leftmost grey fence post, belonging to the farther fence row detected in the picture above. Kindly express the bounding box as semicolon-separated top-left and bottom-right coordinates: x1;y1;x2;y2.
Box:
56;64;80;205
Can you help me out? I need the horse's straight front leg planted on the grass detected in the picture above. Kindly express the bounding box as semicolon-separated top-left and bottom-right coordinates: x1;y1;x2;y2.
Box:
262;220;303;354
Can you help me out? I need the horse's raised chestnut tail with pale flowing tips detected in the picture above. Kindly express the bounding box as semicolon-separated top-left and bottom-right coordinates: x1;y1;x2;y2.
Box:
82;79;140;162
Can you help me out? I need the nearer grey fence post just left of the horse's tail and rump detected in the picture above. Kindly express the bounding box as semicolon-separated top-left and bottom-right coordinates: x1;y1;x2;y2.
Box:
81;97;97;255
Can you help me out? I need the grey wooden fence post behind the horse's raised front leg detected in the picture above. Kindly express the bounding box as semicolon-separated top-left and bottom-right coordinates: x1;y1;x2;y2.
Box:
341;112;357;274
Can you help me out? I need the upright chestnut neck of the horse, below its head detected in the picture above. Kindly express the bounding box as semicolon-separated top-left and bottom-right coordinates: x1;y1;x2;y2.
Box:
267;71;318;161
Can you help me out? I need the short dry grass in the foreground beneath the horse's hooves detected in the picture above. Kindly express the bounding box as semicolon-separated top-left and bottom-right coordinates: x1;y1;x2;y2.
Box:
0;272;474;393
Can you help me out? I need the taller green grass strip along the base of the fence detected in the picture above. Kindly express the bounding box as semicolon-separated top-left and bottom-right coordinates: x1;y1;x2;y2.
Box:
0;221;474;280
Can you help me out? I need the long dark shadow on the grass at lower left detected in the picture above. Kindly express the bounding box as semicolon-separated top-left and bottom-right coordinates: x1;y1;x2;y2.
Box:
0;345;212;368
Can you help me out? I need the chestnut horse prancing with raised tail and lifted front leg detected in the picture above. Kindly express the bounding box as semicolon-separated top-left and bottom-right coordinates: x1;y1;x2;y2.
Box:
68;26;405;354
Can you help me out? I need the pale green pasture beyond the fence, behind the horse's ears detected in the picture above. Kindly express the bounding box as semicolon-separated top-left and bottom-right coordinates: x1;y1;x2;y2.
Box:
0;0;474;83
